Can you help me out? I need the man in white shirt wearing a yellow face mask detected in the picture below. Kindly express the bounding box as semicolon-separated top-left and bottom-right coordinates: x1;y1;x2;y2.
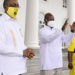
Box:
0;0;34;75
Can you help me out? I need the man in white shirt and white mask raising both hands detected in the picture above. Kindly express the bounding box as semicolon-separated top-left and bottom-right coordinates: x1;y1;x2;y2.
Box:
39;13;75;75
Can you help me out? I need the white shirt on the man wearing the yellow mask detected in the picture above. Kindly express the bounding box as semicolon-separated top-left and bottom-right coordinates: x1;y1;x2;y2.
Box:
0;13;27;75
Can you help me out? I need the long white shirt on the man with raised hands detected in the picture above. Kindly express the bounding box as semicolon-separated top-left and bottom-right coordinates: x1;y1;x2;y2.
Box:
39;25;73;70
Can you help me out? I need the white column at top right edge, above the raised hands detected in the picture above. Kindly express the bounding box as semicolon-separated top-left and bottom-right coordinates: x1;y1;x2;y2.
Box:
68;0;75;24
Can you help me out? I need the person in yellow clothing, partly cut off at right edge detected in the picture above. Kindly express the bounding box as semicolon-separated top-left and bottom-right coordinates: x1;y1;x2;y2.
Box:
68;22;75;75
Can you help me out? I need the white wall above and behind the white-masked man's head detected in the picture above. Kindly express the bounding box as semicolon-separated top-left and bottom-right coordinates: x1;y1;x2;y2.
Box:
39;0;67;28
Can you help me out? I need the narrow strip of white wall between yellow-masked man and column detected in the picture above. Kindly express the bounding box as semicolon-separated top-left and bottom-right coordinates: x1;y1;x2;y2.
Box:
17;0;27;39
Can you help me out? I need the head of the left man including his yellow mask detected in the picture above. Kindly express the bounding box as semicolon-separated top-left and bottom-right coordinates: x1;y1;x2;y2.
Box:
3;0;19;18
